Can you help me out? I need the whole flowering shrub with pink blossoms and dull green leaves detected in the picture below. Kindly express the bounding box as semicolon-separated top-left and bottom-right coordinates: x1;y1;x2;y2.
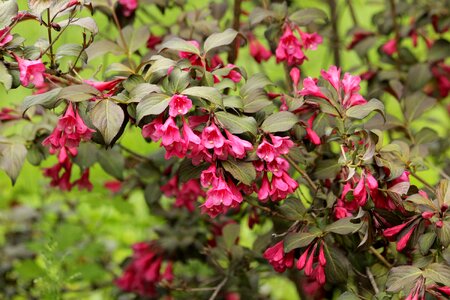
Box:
0;0;450;299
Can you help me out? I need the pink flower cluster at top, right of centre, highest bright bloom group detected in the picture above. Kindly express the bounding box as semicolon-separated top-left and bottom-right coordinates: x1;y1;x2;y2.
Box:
275;24;322;66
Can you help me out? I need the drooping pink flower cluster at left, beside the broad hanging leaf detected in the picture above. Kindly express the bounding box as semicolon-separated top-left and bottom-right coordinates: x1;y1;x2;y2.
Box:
42;102;94;190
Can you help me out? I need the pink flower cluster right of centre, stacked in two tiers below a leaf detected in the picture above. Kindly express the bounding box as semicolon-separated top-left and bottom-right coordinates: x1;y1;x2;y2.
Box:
254;134;298;201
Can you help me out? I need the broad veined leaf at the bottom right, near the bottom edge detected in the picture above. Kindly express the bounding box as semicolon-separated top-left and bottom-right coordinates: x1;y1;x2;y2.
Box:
386;266;422;293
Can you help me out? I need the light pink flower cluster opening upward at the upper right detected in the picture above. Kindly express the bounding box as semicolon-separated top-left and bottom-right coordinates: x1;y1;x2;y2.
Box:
300;66;367;109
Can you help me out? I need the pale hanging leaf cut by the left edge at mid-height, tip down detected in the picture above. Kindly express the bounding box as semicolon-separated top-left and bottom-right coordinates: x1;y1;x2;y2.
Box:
0;140;27;185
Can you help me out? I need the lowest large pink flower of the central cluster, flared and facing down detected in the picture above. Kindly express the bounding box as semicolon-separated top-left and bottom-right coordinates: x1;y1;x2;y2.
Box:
202;176;243;218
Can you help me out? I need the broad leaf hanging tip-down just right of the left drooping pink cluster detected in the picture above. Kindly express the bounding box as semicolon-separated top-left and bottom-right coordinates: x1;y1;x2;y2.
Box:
89;99;125;145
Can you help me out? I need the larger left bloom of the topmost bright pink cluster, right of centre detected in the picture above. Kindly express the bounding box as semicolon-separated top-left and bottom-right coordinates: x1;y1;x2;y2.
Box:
275;26;306;66
